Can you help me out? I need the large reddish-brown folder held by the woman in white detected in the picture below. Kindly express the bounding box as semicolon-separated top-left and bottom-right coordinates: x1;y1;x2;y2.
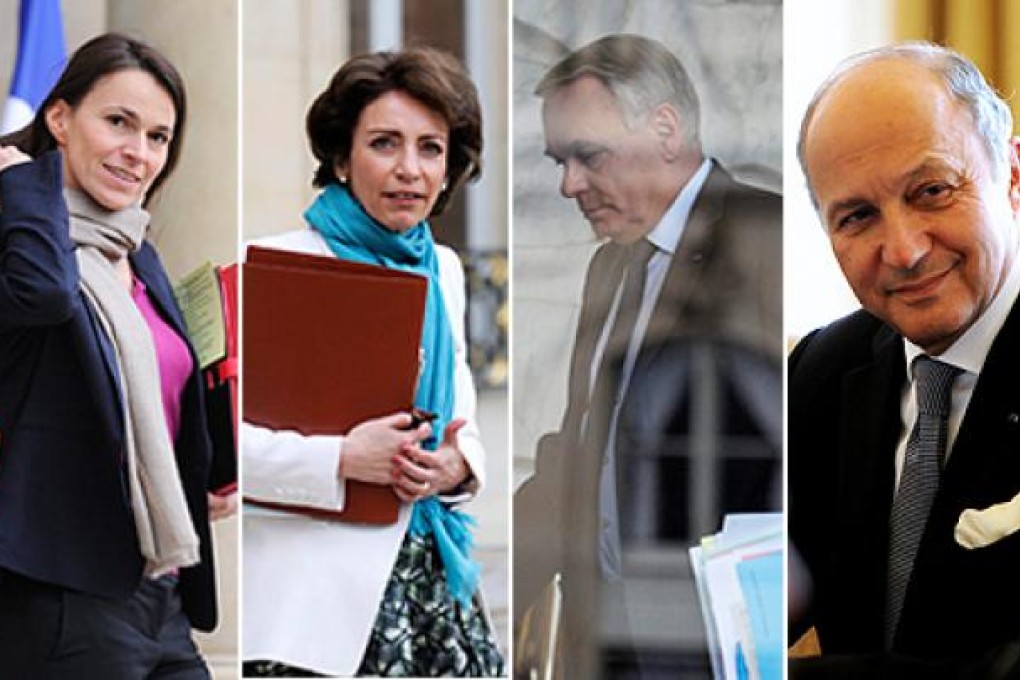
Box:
242;246;428;524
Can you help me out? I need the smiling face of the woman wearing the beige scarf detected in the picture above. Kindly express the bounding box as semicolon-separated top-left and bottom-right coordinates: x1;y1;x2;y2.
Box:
46;68;176;210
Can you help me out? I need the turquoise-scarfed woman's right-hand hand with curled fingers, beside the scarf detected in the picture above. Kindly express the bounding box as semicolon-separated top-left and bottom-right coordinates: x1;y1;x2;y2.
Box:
393;418;470;503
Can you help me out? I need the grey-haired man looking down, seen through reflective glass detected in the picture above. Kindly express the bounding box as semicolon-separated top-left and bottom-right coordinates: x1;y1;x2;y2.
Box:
514;36;781;677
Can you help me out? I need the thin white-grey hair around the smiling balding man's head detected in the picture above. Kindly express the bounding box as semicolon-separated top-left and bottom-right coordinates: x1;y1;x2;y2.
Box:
797;42;1013;209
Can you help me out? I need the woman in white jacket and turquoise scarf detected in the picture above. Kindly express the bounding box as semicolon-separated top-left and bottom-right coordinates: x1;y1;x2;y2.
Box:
242;49;503;677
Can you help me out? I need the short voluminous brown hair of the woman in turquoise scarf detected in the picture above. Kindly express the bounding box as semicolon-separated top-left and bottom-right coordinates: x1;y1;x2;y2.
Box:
306;48;482;216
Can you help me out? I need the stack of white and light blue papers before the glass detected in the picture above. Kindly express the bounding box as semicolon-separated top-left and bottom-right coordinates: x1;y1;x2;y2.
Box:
691;513;785;680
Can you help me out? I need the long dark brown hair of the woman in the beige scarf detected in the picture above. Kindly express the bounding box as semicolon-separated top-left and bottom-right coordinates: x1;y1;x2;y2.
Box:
0;33;188;204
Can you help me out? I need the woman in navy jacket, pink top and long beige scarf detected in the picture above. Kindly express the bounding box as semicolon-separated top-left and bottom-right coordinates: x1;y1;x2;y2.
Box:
0;34;235;680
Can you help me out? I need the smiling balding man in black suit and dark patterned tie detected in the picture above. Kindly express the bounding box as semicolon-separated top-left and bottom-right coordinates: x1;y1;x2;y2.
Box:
788;44;1020;678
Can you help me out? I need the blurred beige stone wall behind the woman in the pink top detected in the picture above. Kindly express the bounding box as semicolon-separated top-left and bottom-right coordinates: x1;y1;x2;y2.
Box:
0;0;239;678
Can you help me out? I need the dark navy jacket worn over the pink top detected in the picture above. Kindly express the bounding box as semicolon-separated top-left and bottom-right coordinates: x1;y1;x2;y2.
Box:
0;152;231;630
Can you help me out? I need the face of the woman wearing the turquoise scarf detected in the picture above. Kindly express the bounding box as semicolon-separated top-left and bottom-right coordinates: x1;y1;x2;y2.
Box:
336;91;449;232
